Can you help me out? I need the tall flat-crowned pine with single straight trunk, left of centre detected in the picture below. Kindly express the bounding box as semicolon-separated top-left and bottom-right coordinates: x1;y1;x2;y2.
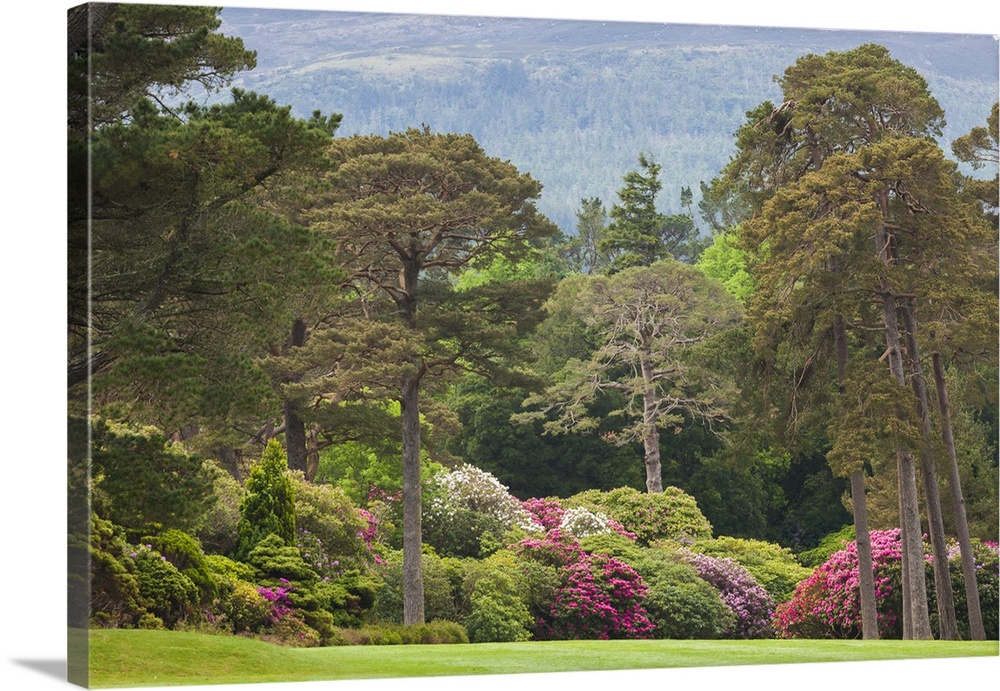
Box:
312;128;556;624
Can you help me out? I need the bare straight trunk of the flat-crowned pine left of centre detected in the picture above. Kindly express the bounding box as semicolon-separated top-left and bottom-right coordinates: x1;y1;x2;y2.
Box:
400;377;424;624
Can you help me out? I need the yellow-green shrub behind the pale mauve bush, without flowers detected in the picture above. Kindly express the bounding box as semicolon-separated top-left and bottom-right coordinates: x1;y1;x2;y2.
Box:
691;537;812;602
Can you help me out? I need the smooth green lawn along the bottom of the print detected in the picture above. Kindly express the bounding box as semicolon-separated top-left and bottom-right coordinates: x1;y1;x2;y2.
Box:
90;630;1000;688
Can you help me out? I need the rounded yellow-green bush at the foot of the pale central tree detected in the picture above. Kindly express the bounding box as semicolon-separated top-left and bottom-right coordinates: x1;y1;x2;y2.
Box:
563;487;712;546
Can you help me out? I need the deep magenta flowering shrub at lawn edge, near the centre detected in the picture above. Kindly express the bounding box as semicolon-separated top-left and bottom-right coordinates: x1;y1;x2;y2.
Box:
516;530;654;640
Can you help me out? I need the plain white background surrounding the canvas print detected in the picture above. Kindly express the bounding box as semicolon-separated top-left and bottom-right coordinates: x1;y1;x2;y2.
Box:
0;0;1000;691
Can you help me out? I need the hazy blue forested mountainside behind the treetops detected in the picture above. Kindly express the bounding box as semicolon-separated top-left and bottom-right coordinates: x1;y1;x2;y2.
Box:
215;9;998;232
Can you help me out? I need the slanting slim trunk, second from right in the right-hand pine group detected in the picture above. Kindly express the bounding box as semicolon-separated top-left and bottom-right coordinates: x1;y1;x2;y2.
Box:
900;298;958;641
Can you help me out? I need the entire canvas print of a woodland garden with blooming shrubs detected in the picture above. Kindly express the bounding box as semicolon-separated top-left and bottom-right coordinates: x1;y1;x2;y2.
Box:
67;3;1000;688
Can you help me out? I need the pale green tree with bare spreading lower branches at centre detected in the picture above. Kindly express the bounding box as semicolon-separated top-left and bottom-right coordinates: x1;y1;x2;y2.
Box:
518;259;740;492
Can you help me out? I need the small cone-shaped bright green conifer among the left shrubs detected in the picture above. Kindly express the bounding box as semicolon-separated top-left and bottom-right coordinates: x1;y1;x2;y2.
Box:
235;439;295;560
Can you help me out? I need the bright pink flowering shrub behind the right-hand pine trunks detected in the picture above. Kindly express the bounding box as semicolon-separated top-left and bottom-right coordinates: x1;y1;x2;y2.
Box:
774;528;902;638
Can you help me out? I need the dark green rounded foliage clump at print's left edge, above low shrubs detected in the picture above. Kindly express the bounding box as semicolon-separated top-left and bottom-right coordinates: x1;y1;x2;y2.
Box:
91;419;215;535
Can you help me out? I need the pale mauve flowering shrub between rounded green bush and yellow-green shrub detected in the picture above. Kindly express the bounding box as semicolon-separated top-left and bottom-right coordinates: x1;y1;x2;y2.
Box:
677;549;774;638
